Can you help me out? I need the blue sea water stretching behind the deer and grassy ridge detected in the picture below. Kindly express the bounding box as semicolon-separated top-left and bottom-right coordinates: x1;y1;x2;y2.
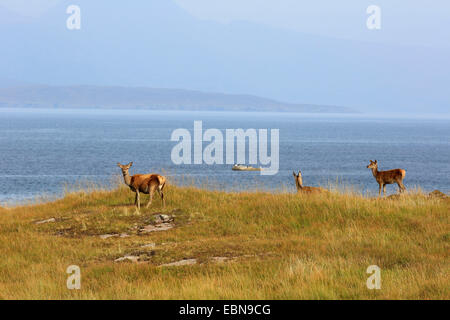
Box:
0;109;450;205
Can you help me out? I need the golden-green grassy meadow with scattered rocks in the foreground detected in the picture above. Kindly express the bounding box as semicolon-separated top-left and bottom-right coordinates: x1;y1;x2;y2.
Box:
0;185;450;299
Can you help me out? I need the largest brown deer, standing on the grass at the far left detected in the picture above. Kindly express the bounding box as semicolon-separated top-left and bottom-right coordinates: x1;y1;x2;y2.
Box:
117;162;166;210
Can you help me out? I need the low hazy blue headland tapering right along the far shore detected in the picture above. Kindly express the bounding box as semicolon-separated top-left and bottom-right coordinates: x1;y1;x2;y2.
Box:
0;85;355;113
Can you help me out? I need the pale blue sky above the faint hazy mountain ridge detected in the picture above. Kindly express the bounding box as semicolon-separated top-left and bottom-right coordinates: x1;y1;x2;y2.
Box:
0;0;450;48
